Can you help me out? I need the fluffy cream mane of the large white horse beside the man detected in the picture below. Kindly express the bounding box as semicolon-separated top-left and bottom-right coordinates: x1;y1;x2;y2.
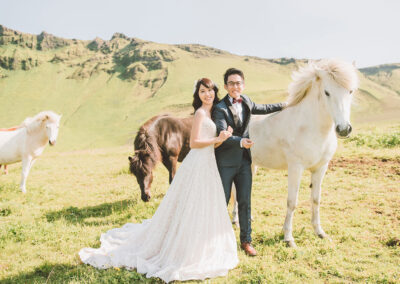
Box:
288;59;358;106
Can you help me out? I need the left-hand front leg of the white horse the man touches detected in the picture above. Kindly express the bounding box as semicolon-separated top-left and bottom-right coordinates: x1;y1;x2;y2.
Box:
283;165;303;247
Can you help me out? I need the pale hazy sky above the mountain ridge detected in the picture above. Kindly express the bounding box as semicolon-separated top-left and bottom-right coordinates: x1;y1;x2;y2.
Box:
0;0;400;67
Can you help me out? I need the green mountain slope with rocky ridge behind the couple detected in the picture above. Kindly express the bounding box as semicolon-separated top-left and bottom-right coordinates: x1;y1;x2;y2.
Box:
0;25;400;150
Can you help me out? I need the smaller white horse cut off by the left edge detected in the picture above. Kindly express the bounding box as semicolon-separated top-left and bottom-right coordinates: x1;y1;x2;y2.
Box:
0;111;61;193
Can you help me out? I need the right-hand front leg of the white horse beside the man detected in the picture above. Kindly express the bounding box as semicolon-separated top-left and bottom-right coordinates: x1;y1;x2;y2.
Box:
311;163;328;238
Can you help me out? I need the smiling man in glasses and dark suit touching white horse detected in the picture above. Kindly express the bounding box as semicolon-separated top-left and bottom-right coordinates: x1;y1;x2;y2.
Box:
213;68;286;256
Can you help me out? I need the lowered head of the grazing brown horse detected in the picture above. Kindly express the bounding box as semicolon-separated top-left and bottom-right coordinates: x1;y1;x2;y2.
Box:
128;150;153;202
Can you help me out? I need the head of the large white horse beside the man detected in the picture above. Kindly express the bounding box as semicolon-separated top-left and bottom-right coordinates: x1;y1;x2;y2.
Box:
316;60;358;138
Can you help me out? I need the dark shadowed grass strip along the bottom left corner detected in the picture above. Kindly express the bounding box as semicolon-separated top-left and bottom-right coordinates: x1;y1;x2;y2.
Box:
0;263;163;284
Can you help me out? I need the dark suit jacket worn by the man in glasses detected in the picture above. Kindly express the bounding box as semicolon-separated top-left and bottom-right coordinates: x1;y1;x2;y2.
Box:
212;95;282;167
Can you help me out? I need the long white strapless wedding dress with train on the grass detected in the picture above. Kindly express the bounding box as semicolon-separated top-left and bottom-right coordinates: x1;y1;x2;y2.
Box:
79;118;238;282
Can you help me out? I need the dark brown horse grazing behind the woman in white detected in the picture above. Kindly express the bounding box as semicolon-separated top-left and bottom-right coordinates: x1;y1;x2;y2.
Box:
128;115;193;202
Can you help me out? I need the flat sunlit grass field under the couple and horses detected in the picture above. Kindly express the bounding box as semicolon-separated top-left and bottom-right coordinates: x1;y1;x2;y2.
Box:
0;123;400;283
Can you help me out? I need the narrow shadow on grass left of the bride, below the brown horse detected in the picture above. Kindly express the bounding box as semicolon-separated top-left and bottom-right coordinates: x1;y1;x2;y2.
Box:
46;199;137;226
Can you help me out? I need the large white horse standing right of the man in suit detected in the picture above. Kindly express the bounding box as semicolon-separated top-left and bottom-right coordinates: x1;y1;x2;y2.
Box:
233;59;358;247
